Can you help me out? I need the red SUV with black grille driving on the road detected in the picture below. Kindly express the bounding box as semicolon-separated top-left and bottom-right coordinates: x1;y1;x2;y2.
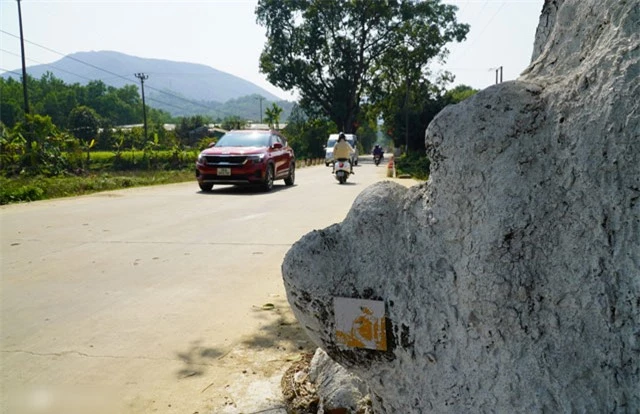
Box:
196;130;296;191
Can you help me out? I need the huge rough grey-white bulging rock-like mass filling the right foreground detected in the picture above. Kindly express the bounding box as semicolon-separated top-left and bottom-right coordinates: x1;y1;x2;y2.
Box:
283;0;640;413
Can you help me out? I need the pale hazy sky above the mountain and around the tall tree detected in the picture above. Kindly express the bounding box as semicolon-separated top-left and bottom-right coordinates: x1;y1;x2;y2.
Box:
0;0;544;99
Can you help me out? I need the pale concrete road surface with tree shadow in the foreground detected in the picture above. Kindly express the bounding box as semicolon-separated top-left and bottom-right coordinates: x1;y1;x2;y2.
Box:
0;159;418;414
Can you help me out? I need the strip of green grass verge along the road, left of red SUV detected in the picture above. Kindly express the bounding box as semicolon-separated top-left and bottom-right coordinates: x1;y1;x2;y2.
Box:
0;168;195;205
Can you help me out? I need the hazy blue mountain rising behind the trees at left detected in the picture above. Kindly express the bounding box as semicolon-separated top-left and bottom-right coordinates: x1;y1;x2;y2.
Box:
0;51;291;118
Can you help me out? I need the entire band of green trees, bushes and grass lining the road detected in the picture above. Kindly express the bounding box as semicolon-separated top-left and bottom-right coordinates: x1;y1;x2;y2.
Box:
0;0;477;204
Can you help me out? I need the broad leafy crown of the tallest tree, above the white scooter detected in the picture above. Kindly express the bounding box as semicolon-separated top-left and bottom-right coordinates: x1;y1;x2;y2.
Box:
256;0;468;132
